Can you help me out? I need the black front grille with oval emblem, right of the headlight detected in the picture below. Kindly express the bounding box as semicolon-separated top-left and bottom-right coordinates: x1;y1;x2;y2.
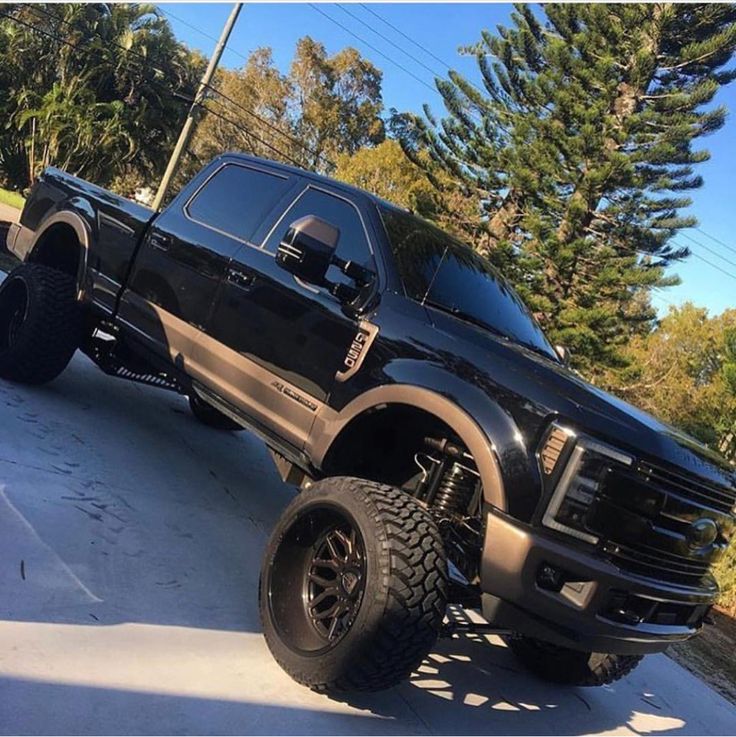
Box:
586;463;736;587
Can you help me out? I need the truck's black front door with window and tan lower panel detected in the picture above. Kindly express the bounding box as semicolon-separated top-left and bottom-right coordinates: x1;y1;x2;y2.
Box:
197;185;376;447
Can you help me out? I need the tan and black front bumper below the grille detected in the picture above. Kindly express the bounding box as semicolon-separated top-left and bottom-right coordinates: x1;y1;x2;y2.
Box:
481;510;717;654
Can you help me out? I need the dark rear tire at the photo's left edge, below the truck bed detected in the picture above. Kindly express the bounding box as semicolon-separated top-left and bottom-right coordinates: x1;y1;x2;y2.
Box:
0;264;82;384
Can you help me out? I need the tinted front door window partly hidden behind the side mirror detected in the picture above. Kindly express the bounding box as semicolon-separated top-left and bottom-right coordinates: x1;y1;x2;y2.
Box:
264;189;375;284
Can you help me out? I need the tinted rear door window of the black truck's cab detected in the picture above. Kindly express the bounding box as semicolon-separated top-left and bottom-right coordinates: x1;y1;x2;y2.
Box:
185;164;289;241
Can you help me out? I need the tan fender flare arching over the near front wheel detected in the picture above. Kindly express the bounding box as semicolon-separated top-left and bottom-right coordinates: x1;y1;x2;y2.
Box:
307;384;507;511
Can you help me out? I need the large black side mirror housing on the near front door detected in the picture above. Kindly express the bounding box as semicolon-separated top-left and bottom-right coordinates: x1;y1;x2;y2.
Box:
276;215;340;286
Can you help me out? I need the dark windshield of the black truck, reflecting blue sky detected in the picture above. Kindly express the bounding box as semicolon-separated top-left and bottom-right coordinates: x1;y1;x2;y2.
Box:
378;205;559;361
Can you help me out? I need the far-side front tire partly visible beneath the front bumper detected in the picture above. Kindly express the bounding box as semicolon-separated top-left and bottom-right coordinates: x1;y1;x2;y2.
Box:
508;635;644;686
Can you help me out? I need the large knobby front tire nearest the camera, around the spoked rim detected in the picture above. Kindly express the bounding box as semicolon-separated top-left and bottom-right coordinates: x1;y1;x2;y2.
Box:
259;477;447;692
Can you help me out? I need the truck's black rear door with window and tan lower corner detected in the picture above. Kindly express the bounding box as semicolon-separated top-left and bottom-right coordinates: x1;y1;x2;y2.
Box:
118;160;296;366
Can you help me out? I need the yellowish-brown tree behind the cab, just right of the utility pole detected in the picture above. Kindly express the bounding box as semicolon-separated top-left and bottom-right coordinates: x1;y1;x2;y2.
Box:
185;36;384;178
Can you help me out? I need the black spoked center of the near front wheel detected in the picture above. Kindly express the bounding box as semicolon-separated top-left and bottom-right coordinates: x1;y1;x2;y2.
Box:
305;522;365;644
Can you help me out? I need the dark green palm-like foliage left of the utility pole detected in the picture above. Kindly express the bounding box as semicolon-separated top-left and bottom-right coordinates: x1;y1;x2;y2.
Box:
0;3;203;189
